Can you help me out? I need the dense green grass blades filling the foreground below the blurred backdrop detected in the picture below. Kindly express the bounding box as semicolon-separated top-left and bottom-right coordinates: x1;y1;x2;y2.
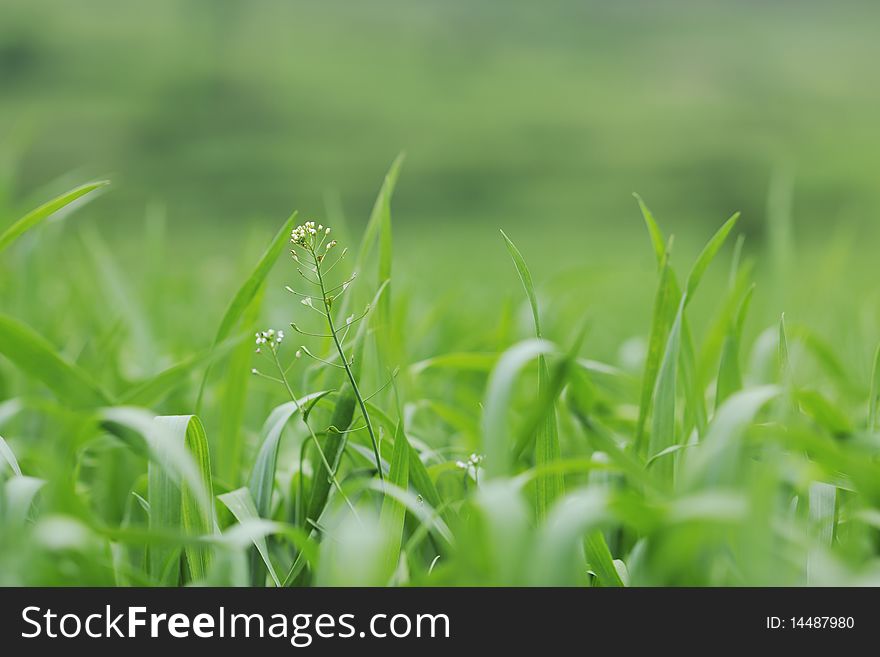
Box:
0;165;880;586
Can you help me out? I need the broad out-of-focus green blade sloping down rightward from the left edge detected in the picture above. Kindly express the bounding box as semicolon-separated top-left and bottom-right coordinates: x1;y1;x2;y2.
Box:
0;315;110;408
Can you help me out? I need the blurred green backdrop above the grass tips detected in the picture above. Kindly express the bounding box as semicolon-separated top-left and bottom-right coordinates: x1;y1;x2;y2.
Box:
0;0;880;358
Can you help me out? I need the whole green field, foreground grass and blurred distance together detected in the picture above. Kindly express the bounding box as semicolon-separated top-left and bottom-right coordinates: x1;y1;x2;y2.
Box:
0;0;880;586
